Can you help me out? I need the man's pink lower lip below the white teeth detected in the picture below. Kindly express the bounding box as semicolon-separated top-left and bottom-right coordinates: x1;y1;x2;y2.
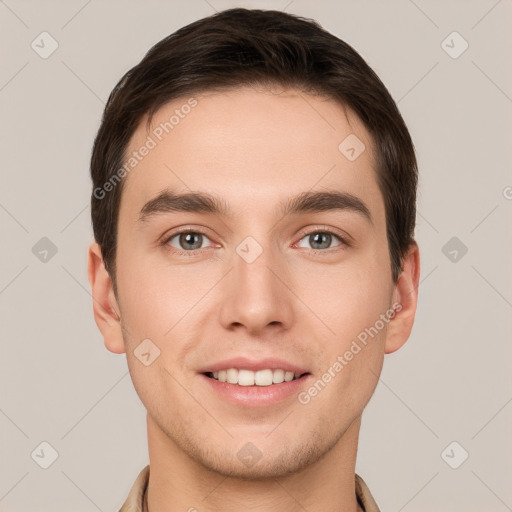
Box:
200;374;311;407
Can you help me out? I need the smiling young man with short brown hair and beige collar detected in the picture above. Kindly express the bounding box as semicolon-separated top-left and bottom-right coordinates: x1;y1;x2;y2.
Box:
88;9;419;512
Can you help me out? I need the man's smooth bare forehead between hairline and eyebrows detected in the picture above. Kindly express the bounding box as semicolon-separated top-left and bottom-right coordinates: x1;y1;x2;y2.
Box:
121;87;382;222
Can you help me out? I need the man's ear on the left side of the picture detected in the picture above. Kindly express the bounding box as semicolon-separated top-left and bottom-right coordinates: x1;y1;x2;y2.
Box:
87;243;125;354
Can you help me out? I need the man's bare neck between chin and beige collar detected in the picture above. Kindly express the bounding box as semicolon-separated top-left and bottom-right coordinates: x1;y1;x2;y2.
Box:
147;414;362;512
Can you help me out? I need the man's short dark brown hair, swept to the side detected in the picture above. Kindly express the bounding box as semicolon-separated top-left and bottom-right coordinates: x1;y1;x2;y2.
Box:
91;8;418;289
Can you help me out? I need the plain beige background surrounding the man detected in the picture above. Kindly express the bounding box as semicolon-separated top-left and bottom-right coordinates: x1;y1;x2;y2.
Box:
0;0;512;512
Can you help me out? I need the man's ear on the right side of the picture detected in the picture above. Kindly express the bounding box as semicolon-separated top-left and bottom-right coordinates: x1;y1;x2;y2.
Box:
384;242;420;354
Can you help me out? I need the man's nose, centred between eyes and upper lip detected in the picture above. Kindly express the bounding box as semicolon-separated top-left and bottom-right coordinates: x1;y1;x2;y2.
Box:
220;240;294;335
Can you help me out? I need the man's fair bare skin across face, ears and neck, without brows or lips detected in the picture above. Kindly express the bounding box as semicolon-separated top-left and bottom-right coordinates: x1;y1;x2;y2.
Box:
88;87;420;512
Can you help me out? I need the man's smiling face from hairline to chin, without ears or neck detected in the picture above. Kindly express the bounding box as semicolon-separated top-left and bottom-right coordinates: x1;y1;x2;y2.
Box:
91;88;412;477
